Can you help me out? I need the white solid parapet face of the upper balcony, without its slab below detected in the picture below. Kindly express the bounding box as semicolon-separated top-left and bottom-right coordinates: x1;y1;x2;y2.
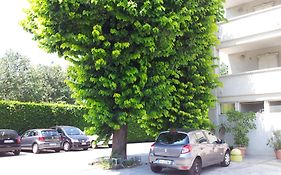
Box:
219;5;281;42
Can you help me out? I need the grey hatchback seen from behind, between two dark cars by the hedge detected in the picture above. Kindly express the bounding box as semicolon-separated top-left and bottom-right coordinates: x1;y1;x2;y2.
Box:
21;129;61;154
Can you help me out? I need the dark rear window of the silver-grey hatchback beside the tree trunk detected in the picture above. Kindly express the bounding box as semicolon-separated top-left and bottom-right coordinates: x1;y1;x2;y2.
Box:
156;132;189;145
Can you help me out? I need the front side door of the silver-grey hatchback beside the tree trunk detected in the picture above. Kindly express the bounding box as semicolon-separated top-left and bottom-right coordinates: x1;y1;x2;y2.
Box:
204;131;224;164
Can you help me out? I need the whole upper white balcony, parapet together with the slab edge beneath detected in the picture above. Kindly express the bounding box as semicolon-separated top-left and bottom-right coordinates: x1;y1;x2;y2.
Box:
218;5;281;53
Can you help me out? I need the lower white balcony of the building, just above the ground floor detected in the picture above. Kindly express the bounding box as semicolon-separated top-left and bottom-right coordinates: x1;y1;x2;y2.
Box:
217;67;281;102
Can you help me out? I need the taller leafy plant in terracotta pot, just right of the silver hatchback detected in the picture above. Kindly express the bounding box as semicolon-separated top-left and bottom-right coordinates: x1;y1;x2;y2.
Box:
225;111;256;157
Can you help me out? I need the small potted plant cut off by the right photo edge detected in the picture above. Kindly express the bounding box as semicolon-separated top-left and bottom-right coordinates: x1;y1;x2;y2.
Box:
267;130;281;159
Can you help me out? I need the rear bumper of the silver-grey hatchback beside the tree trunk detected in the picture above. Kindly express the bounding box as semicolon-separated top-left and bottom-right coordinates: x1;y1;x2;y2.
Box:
148;154;194;170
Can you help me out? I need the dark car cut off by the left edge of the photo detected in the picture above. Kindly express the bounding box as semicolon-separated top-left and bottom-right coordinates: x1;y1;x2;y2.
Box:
0;129;21;156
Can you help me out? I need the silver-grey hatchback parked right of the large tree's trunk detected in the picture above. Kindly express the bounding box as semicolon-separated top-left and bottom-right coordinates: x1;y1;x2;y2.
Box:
149;130;230;175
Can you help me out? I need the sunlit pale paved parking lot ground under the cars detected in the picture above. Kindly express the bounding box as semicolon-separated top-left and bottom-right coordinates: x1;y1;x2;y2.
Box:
0;143;281;175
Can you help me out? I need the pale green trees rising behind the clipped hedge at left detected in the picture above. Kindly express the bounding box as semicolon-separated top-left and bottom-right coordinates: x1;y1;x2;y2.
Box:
0;50;74;103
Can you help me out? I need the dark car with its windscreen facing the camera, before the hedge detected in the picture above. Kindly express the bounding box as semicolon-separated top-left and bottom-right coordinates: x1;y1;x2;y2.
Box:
52;126;91;151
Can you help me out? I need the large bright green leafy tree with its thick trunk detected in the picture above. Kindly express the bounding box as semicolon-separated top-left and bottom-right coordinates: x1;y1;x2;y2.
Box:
22;0;223;158
